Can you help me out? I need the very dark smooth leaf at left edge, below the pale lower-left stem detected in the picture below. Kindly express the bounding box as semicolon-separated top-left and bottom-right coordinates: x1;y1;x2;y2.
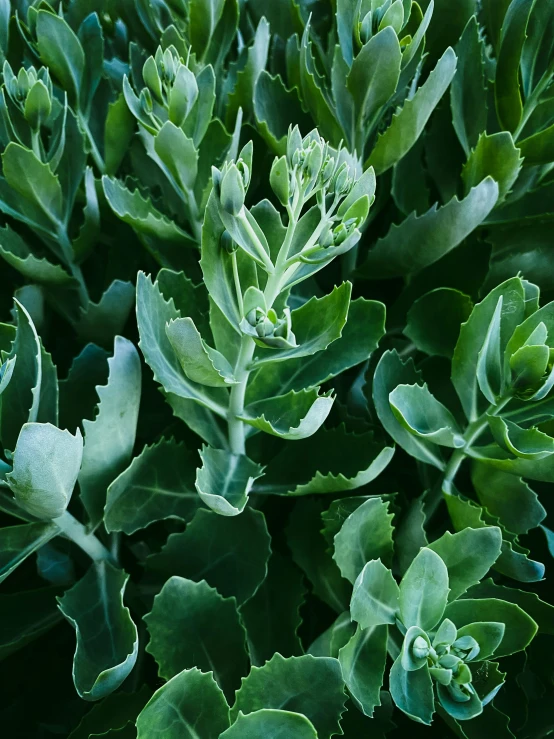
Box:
0;587;62;660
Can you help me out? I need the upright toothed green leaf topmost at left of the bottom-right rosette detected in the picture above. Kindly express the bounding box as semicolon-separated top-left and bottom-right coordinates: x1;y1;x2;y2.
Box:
333;498;394;583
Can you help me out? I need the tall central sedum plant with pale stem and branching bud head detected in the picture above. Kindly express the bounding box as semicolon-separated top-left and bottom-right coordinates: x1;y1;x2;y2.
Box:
137;128;392;515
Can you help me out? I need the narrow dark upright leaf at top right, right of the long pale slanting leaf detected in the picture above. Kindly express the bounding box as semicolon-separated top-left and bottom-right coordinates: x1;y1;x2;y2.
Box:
450;16;487;156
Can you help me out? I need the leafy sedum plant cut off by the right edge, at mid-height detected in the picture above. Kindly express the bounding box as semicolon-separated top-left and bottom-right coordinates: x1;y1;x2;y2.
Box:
373;277;554;582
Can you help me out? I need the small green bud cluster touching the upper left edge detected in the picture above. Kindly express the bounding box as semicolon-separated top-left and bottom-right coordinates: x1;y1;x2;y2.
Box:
2;61;53;131
